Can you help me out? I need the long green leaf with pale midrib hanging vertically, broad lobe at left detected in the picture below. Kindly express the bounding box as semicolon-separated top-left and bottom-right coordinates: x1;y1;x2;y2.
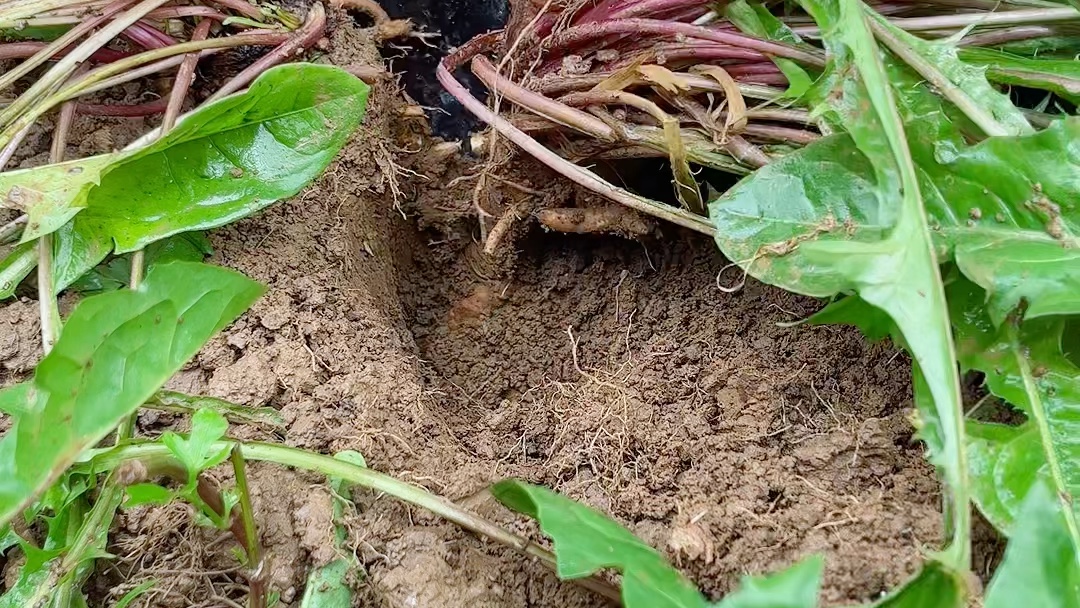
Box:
710;0;968;569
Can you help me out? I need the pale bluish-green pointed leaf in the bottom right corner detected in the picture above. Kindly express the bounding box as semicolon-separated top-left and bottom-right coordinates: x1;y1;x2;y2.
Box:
983;483;1080;608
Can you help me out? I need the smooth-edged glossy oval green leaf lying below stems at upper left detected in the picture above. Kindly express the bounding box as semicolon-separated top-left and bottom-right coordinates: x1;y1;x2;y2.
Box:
76;64;368;253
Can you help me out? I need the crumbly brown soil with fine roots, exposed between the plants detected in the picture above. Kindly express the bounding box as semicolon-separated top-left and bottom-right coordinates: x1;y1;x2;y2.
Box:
0;5;941;608
